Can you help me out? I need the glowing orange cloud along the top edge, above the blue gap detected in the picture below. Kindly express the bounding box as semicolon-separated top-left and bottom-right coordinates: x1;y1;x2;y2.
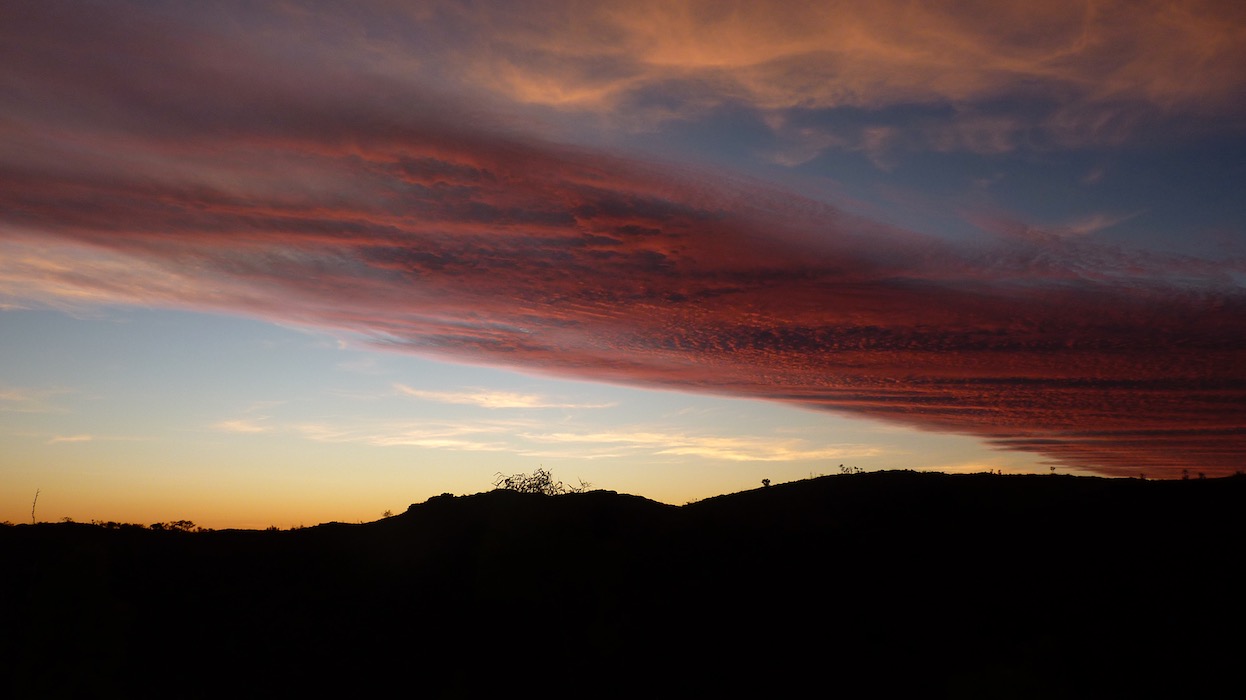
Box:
457;0;1246;132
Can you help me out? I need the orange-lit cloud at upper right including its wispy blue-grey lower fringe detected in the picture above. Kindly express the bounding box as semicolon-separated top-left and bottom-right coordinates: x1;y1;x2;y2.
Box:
441;0;1246;153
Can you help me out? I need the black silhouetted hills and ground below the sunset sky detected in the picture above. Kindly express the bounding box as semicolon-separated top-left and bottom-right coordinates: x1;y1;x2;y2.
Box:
0;472;1246;698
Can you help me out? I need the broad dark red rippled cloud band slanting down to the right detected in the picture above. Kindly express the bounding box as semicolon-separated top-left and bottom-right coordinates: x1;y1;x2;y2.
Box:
7;0;1246;476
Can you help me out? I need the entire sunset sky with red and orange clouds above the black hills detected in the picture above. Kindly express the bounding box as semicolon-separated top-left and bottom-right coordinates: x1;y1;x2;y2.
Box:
0;0;1246;527
